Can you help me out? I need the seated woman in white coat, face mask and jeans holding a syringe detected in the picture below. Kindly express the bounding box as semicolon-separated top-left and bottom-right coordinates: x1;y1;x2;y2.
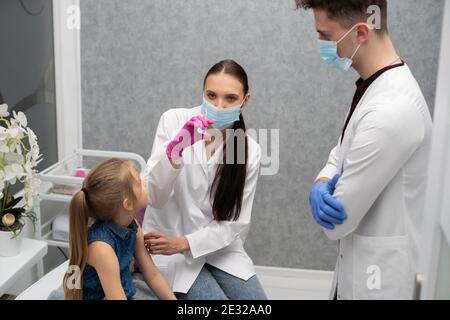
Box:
143;60;266;300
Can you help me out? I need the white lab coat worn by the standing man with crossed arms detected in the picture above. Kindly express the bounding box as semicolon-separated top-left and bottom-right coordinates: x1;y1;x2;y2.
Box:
318;65;432;300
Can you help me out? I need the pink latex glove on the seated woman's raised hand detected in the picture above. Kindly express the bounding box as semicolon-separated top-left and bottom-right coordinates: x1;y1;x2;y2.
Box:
166;116;214;161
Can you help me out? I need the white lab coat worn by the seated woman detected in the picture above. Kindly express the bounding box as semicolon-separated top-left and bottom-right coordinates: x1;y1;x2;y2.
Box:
143;107;261;293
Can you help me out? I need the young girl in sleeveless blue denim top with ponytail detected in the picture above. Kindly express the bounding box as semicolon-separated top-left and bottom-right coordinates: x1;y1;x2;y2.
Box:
64;159;176;300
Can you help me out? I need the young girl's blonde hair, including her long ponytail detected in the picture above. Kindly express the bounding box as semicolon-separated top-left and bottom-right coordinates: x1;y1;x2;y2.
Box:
63;159;139;300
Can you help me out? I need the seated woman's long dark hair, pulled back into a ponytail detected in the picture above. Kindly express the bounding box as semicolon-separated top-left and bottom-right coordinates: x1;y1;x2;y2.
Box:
204;60;249;221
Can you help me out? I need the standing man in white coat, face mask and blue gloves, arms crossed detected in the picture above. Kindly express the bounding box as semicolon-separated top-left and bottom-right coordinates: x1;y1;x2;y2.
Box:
296;0;432;299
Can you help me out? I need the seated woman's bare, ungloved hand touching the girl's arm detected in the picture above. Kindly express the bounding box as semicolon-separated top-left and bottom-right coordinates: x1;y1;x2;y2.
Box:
144;231;190;256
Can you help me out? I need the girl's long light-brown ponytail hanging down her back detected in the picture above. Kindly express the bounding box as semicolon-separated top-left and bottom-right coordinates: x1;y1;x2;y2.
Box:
63;190;89;300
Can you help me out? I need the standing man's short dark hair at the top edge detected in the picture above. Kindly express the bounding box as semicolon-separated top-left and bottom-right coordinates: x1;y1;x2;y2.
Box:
295;0;388;33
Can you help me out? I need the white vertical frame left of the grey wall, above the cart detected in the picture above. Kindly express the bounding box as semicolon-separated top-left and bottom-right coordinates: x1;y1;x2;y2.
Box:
53;0;83;161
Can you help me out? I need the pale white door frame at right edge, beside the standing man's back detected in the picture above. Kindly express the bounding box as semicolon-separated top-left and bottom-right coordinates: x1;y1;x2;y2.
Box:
416;1;450;300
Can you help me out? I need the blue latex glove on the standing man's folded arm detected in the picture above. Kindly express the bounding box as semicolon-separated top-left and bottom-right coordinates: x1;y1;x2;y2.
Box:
309;175;347;230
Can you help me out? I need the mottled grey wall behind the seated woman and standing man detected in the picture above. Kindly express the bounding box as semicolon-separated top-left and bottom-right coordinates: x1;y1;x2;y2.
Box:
81;0;444;269
